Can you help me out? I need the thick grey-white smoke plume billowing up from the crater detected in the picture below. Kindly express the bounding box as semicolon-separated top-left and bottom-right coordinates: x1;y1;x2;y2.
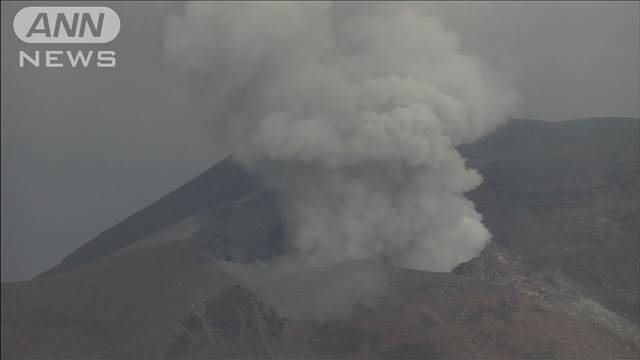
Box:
165;2;514;271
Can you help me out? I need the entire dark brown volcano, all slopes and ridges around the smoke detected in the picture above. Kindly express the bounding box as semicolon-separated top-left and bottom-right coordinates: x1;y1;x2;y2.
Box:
1;118;640;359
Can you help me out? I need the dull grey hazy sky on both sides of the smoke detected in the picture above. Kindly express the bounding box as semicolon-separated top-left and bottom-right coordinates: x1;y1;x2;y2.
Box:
1;1;640;281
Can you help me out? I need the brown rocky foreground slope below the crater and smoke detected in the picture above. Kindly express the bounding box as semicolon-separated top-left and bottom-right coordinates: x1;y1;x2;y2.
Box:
2;240;640;359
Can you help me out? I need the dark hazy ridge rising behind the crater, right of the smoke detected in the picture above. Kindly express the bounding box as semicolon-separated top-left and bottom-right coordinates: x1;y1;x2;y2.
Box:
461;119;640;323
